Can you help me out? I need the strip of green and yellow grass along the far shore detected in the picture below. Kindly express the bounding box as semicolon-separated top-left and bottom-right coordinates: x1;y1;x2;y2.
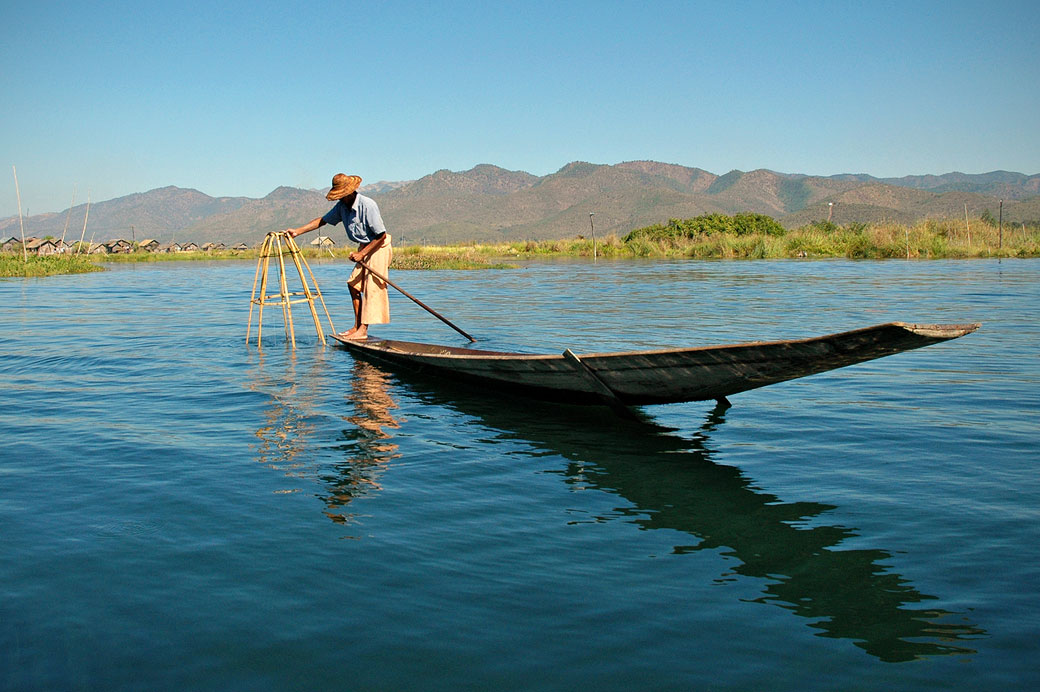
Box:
0;220;1040;277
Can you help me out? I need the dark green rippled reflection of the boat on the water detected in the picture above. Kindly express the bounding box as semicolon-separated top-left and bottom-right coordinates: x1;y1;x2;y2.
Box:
372;377;985;662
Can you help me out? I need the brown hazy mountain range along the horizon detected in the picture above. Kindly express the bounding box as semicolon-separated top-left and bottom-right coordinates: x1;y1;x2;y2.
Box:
0;161;1040;245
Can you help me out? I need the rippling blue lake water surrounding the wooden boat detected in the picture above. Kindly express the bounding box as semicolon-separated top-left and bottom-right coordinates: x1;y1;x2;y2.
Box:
0;255;1040;691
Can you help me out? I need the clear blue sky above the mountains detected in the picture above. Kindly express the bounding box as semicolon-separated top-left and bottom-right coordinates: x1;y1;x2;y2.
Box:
0;0;1040;216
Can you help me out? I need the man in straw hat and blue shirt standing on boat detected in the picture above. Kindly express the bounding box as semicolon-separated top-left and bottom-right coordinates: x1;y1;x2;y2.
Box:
285;173;393;340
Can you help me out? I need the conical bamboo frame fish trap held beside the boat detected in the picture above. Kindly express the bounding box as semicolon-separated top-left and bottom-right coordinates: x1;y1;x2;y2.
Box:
245;231;336;349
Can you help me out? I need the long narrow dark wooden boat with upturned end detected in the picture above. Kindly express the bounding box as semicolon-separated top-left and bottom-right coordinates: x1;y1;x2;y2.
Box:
334;322;979;407
